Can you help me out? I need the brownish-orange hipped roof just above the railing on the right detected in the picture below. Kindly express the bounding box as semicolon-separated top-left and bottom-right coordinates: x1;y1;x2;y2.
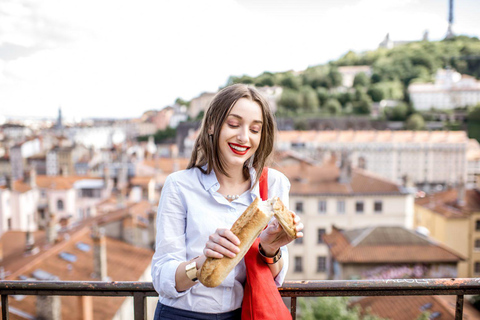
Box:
324;227;465;263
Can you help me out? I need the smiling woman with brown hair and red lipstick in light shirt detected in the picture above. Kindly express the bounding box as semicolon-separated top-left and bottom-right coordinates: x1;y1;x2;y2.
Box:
152;84;303;319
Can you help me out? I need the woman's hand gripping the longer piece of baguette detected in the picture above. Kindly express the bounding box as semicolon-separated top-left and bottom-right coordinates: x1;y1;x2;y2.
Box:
203;229;240;258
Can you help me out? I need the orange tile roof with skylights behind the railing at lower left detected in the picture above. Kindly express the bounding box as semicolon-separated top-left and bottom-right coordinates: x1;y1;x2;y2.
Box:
6;228;153;319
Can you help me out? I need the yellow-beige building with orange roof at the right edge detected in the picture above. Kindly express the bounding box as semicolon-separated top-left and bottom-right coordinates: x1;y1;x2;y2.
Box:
415;189;480;278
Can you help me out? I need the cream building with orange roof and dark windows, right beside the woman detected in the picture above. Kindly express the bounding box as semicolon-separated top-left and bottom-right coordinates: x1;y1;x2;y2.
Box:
277;159;414;280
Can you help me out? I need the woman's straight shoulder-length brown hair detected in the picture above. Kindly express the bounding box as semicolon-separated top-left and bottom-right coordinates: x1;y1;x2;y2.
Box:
187;84;275;185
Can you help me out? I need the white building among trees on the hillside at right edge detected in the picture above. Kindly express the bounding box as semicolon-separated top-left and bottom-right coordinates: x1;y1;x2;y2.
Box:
408;69;480;110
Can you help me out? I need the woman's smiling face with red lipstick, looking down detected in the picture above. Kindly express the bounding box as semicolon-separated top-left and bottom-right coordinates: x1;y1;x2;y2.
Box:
218;98;263;170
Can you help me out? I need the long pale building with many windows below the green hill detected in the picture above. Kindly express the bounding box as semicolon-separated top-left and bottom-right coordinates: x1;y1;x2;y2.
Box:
276;130;469;189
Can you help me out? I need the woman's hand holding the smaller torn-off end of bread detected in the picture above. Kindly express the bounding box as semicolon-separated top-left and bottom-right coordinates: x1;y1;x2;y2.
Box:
260;211;303;256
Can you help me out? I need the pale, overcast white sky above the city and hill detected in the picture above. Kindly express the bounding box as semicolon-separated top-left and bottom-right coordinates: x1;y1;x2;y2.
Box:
0;0;480;120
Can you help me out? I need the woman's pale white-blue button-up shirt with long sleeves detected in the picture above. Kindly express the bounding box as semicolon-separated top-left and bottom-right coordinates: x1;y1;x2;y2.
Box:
152;168;290;313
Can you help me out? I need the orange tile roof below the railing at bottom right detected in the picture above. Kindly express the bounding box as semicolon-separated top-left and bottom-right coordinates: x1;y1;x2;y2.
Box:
352;296;480;320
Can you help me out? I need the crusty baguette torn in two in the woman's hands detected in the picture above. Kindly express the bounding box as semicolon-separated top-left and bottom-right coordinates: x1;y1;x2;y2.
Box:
198;197;297;287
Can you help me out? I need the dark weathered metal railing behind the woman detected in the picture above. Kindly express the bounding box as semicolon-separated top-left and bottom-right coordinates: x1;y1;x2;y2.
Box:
0;278;480;320
